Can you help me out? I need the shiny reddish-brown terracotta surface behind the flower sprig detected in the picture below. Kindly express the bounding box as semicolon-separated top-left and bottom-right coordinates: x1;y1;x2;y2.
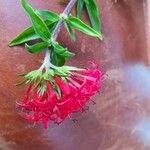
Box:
0;0;150;150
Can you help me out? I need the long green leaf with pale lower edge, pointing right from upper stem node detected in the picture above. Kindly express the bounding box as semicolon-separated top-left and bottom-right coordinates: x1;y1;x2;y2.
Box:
66;15;102;39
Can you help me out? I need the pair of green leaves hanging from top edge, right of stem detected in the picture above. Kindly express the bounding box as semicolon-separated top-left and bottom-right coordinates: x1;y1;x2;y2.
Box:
77;0;101;33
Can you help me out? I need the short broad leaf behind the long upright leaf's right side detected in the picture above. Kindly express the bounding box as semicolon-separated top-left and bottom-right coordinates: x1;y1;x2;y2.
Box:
36;10;60;22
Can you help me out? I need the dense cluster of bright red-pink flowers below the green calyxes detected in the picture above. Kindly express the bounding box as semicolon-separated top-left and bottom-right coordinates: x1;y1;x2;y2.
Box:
17;63;102;128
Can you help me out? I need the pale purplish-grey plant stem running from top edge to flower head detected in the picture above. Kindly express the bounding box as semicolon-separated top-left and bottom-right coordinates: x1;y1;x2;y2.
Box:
41;0;77;69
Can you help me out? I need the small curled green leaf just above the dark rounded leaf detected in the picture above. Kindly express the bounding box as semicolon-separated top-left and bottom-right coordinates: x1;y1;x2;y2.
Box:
52;42;74;57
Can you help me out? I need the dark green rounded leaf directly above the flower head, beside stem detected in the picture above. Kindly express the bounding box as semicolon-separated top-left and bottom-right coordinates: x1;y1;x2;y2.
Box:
51;49;65;66
